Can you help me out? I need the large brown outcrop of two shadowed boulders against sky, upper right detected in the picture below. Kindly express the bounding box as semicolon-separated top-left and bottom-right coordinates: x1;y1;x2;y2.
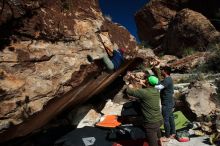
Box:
135;0;220;57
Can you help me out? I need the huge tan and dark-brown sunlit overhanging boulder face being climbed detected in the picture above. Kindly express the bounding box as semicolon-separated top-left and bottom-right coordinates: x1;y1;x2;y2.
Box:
0;0;137;134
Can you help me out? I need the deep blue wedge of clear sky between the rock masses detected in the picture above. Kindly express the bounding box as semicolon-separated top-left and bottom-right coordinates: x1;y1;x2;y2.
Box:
99;0;148;41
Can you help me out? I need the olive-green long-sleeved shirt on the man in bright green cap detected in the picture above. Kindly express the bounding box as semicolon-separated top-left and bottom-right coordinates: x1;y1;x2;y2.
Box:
127;88;162;123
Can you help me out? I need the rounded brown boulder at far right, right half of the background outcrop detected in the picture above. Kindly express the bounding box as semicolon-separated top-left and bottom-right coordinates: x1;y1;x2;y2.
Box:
162;9;220;56
